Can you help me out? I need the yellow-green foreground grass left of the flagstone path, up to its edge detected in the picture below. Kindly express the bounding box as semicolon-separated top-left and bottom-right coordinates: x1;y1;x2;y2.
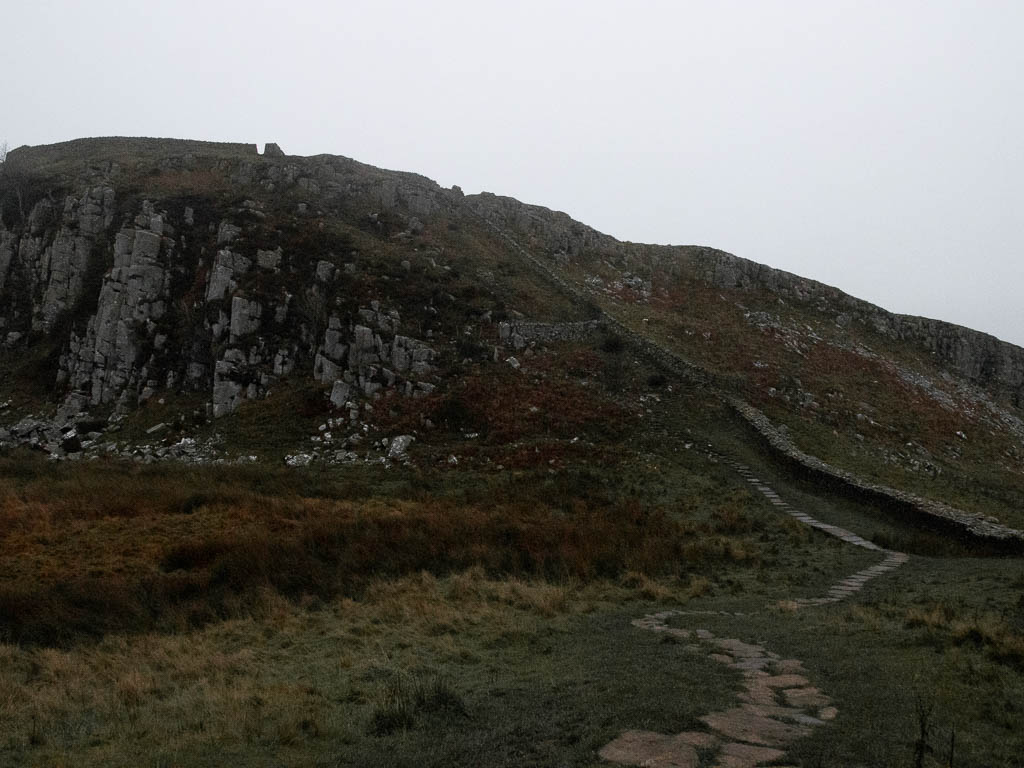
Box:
0;569;734;766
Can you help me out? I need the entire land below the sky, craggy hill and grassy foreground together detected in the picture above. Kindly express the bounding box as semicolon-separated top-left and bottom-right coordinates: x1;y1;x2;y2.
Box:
0;138;1024;766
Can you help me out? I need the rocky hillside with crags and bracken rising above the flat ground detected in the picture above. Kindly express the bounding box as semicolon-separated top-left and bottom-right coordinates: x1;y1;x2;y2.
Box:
0;138;1024;526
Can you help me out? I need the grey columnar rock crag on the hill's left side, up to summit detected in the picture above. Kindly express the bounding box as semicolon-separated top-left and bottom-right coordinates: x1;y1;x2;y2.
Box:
0;139;456;417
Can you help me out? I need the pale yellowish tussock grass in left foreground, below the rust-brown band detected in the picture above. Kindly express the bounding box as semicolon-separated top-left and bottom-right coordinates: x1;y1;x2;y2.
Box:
0;566;720;766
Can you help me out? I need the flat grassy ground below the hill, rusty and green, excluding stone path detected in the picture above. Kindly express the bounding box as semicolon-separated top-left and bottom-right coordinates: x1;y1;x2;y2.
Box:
0;442;1024;766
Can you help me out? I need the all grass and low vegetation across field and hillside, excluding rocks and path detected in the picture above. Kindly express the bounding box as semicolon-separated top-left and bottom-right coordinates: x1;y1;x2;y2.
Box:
6;163;1024;767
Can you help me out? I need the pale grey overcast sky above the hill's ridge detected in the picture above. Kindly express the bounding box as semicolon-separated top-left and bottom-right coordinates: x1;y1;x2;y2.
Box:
0;0;1024;344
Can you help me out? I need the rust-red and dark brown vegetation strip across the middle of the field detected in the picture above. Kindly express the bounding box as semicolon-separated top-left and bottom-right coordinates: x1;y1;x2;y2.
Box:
0;462;745;644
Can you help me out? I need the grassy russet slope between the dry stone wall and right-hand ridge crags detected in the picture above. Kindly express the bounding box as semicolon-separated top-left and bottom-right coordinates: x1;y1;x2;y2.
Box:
570;256;1024;527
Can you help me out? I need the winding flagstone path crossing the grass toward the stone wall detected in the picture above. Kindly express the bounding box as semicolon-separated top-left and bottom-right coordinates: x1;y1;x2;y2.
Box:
598;452;909;768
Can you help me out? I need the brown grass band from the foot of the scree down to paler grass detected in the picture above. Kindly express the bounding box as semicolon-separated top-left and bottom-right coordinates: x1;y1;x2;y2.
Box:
0;444;786;646
